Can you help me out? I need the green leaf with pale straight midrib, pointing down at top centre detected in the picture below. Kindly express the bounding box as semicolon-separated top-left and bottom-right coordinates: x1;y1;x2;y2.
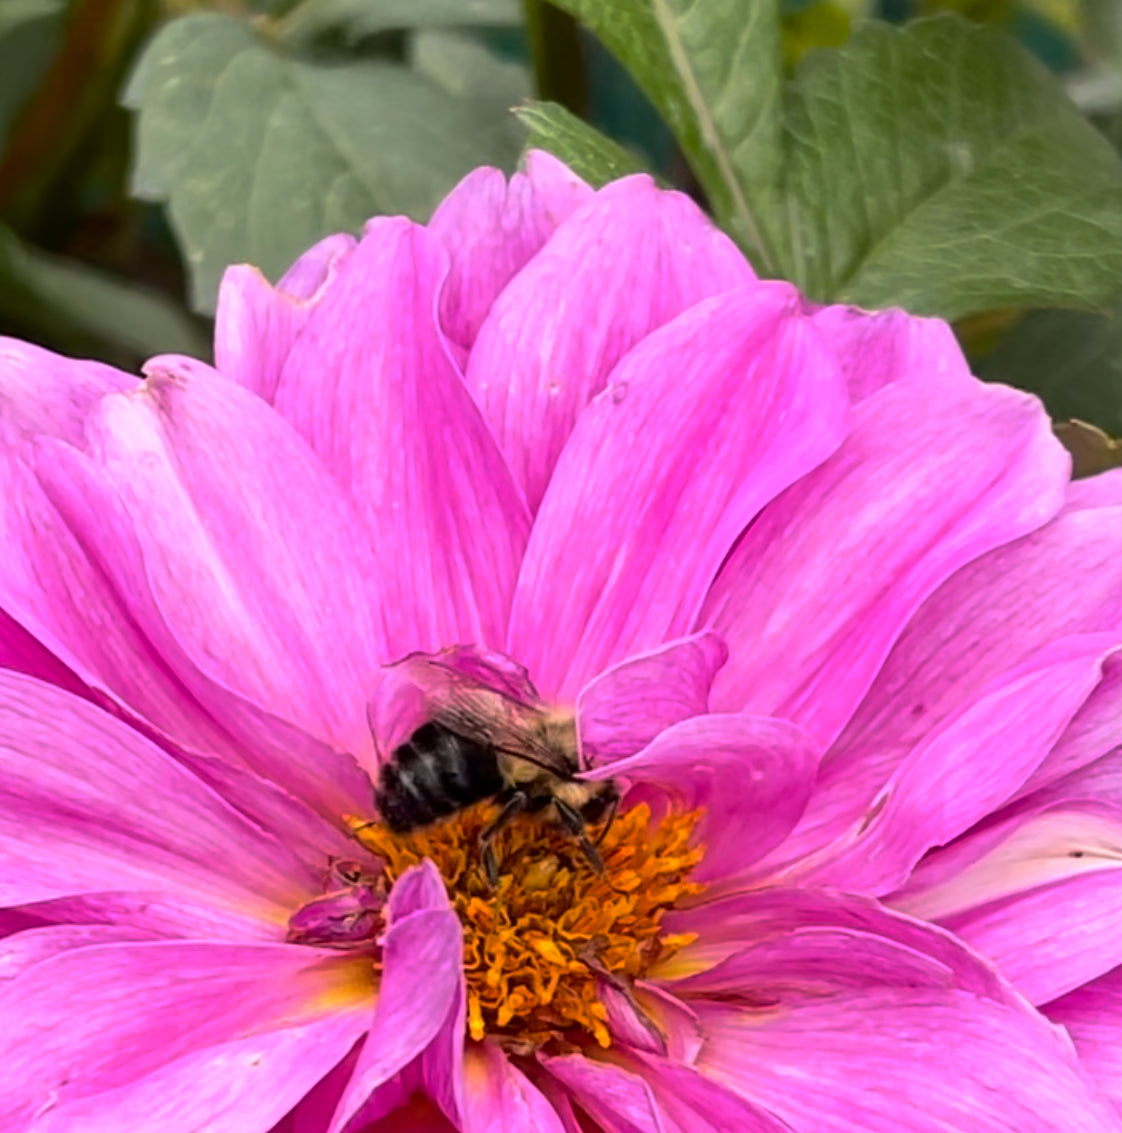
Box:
555;0;782;272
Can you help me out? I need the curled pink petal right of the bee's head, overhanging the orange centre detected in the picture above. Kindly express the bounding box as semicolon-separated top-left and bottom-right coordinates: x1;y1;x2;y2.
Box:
587;715;819;881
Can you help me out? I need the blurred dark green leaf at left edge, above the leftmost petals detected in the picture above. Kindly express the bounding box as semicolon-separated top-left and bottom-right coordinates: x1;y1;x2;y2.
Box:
0;227;210;366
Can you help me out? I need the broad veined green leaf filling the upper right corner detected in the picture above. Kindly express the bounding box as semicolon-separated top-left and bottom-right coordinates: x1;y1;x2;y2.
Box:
785;17;1122;318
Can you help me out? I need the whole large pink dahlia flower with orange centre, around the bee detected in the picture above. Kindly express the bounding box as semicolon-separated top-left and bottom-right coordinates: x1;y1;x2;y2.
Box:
0;154;1122;1133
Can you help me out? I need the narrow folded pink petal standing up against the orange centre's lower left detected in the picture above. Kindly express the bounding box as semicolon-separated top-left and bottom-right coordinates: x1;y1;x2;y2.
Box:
330;862;464;1133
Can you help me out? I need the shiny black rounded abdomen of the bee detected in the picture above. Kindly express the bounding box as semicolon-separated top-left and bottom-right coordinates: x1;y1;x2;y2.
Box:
374;723;503;834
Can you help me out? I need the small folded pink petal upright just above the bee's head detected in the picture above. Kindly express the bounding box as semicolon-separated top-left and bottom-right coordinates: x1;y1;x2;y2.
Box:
577;633;729;761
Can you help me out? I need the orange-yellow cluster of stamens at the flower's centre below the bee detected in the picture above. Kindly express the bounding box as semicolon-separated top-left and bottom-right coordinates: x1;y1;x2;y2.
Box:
349;803;704;1050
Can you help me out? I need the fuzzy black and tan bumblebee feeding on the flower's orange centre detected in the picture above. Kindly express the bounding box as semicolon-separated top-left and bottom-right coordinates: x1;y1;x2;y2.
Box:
374;679;620;886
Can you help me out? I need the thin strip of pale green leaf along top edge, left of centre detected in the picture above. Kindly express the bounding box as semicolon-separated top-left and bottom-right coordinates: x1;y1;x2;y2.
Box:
278;0;520;43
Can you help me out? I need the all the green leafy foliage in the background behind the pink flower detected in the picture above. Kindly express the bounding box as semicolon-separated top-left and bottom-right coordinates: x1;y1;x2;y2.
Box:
0;0;1122;446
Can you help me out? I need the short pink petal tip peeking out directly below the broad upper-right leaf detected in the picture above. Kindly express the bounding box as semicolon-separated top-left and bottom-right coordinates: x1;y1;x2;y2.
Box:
814;306;974;403
